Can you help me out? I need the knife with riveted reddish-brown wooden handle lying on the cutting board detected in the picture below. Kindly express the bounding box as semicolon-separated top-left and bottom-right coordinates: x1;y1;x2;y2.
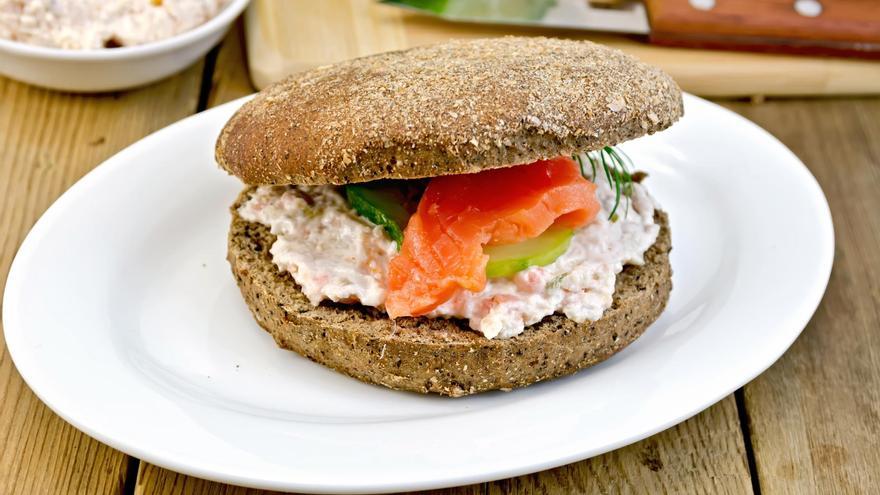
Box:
380;0;880;58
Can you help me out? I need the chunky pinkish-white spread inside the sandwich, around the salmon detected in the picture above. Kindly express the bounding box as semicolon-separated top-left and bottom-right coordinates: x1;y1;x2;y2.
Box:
238;165;660;338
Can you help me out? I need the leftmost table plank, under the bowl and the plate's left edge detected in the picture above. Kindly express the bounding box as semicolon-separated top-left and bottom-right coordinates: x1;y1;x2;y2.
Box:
0;65;201;494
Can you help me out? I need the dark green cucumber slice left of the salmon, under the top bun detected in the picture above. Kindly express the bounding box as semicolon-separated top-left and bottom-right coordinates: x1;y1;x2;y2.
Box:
345;182;410;249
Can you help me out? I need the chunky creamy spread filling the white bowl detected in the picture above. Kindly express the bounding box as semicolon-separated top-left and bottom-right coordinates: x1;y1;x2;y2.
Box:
0;0;228;50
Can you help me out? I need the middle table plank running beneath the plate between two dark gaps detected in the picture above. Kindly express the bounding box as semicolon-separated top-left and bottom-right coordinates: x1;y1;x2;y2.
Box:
136;23;751;495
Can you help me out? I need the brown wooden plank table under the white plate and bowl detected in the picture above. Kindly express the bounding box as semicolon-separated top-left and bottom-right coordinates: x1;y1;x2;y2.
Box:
0;23;880;494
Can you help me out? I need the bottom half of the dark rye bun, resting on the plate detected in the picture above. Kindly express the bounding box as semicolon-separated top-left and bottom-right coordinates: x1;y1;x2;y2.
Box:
227;189;672;397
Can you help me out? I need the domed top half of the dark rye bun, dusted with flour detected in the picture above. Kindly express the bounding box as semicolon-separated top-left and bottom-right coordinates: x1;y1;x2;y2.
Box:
216;37;683;185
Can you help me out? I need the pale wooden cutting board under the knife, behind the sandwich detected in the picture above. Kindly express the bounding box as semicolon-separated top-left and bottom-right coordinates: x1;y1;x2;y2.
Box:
245;0;880;97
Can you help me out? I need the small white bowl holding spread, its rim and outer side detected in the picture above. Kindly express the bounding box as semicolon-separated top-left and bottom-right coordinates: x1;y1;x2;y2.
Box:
0;0;249;92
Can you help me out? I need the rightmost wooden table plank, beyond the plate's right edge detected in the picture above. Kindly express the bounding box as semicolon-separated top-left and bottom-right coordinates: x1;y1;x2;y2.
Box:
729;99;880;493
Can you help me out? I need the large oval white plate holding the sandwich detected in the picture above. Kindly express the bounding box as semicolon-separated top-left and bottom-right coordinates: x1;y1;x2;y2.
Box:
3;96;834;492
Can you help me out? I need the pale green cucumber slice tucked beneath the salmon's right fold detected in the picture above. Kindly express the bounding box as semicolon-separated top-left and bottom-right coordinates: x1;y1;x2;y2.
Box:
483;227;574;278
